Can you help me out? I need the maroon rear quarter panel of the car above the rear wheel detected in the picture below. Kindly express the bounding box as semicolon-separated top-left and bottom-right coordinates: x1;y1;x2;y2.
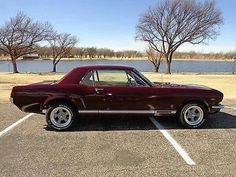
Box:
11;84;83;113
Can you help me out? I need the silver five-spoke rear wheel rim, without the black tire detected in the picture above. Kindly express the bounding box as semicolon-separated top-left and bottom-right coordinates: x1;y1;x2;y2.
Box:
50;106;72;128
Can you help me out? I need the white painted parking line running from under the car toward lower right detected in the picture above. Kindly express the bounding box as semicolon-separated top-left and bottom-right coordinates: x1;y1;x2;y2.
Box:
149;117;196;165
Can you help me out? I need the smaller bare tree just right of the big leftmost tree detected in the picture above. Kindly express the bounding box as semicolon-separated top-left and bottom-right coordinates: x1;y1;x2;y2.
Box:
48;33;78;72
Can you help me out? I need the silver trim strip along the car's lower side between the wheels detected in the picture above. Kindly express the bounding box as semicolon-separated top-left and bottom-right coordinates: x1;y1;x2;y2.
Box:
78;110;176;116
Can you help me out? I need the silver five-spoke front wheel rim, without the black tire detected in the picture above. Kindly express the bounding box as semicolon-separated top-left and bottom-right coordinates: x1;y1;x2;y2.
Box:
183;105;204;126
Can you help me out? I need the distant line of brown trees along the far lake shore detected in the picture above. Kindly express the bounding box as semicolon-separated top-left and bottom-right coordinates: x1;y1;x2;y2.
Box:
0;46;233;62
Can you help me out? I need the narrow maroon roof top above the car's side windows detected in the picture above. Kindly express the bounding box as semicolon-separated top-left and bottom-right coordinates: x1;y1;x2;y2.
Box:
76;65;134;70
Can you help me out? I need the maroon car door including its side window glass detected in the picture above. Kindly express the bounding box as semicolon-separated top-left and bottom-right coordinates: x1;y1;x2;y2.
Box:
95;70;157;113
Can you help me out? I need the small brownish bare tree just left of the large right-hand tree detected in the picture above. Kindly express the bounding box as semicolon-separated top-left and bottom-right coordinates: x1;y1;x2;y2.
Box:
146;47;163;72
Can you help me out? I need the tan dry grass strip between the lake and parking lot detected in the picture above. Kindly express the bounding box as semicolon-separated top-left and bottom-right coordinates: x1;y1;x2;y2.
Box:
0;73;236;102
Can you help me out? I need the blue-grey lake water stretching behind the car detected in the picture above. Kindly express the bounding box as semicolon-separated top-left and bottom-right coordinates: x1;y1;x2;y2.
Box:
0;60;236;73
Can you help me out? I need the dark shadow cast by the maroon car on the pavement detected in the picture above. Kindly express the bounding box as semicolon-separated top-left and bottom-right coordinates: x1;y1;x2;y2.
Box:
45;112;236;132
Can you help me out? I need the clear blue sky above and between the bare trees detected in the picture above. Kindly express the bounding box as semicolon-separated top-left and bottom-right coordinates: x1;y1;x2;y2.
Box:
0;0;236;52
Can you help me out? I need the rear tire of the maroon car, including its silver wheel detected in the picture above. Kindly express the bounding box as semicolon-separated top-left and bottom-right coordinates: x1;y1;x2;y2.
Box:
46;103;78;131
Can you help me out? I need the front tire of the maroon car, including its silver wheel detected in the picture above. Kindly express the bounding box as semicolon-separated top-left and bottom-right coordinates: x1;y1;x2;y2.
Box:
178;103;208;128
